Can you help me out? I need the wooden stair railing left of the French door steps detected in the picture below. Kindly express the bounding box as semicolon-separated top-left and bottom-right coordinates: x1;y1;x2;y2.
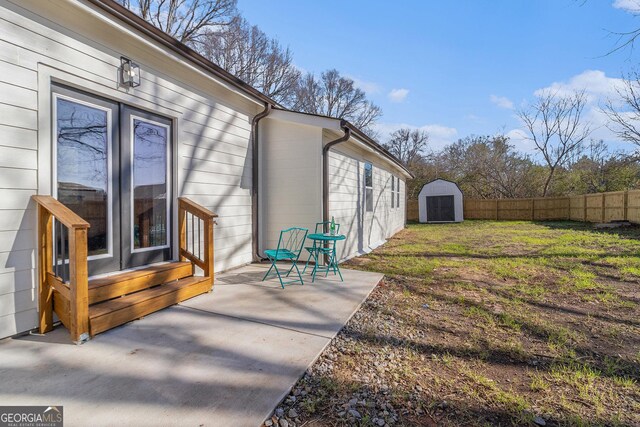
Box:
31;196;90;343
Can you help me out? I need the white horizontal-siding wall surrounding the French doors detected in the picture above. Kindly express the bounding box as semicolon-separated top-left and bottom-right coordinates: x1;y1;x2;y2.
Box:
0;0;260;338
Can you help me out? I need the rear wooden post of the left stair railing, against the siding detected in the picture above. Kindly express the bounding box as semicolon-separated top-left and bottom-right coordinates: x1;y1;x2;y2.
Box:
38;205;53;334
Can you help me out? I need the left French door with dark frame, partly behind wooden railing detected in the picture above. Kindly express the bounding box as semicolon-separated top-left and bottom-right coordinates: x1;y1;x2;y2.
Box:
52;85;120;274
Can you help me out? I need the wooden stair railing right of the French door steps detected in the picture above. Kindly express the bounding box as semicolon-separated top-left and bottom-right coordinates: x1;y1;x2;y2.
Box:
178;197;218;286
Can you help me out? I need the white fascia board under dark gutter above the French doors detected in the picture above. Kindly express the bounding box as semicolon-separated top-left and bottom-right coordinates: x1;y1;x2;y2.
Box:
72;2;264;106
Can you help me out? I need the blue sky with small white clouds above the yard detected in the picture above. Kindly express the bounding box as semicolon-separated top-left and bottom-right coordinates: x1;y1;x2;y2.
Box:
238;0;640;152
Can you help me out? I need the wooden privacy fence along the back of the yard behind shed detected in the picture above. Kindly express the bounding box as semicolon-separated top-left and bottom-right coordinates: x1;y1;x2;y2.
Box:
407;190;640;223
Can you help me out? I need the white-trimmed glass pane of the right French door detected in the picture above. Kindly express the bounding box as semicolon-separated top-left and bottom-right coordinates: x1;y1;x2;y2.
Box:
132;117;169;251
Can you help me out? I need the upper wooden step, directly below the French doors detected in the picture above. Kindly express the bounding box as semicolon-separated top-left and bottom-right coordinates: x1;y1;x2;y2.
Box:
89;261;193;305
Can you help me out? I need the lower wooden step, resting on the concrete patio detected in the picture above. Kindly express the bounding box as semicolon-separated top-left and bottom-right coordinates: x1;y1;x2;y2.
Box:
89;276;212;336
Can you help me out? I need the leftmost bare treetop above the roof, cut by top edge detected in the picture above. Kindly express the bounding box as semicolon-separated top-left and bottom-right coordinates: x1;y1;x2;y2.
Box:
116;0;237;47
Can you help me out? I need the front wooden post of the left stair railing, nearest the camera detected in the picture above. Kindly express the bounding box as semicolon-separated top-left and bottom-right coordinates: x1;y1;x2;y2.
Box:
69;228;89;344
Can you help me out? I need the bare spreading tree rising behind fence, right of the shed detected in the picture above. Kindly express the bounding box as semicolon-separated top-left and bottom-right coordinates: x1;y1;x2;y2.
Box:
518;91;591;197
